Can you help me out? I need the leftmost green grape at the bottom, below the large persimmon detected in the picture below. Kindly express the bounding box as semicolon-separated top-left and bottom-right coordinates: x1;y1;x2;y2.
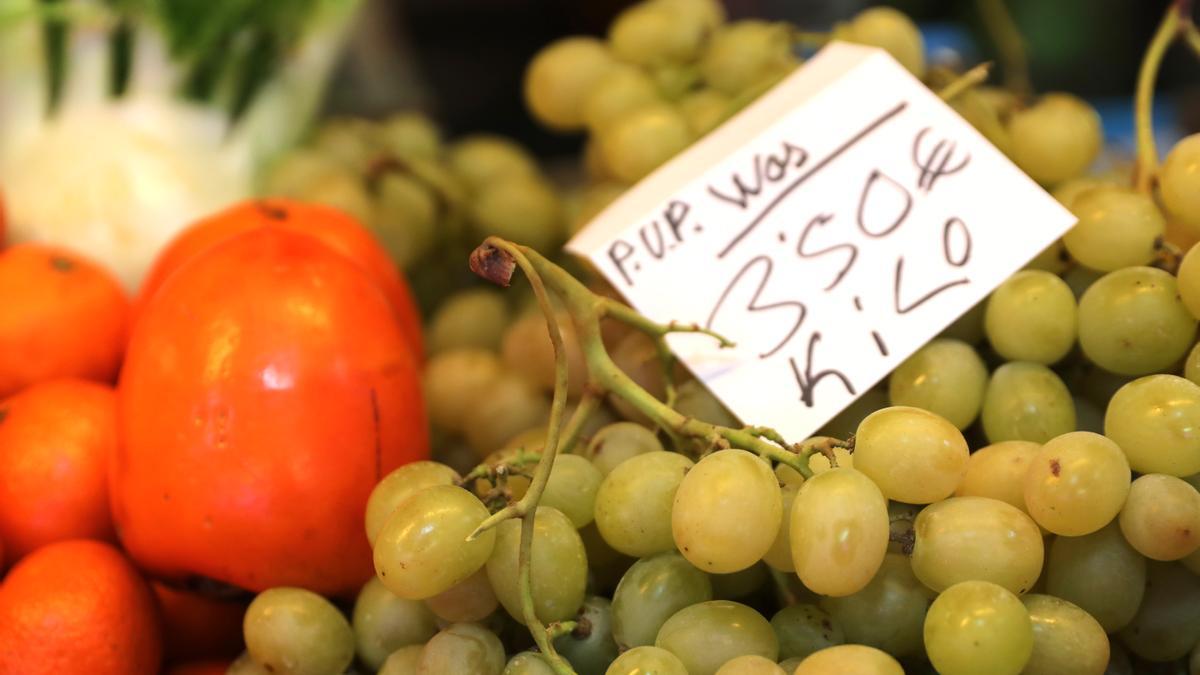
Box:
242;586;354;675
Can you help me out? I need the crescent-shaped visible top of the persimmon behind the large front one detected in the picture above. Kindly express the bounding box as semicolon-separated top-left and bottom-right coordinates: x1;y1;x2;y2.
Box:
134;198;424;358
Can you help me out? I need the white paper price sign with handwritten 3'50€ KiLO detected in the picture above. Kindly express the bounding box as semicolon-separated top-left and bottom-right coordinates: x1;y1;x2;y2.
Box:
568;43;1075;440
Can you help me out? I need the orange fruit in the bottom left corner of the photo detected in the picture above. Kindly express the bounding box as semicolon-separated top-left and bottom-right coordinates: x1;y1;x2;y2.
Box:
0;539;162;675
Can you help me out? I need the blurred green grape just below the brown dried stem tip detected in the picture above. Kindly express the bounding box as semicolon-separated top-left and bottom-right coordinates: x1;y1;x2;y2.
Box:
425;288;509;354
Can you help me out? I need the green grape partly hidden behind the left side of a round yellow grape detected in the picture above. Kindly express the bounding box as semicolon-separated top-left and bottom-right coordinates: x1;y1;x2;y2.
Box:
595;452;692;556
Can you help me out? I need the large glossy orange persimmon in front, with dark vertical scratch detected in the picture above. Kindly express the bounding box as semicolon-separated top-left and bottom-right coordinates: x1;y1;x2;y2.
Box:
109;227;428;596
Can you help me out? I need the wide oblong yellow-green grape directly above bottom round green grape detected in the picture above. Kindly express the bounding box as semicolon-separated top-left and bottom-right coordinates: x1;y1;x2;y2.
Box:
912;497;1043;595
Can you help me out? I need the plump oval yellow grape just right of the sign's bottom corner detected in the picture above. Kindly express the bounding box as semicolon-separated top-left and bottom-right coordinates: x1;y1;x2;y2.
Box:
854;406;970;504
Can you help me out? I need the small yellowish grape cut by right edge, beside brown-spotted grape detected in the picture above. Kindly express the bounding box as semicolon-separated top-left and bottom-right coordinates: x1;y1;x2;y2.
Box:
1118;473;1200;560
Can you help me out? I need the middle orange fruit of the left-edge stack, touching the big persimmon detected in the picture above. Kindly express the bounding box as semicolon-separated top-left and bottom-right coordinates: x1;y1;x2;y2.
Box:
0;378;116;561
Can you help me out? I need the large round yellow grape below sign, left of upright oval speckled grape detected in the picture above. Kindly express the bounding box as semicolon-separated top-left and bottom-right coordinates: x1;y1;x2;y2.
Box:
671;449;782;574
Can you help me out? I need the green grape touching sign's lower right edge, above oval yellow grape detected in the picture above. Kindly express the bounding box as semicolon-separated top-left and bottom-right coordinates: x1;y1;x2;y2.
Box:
888;338;988;429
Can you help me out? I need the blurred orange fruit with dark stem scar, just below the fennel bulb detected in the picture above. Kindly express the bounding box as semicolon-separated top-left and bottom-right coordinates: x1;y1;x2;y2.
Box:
0;244;130;398
